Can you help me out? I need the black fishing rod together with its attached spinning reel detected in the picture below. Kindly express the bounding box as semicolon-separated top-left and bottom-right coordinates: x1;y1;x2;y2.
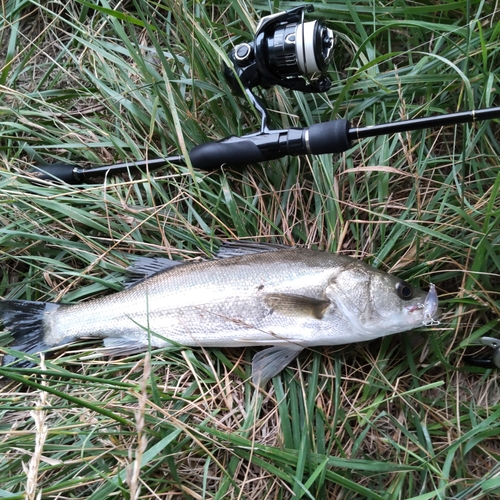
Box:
33;5;500;184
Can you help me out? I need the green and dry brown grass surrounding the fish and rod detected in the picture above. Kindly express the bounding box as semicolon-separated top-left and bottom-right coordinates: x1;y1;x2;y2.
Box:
0;0;500;500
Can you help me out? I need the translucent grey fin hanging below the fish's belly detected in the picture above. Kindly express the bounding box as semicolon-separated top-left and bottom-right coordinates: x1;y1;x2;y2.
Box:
252;344;303;387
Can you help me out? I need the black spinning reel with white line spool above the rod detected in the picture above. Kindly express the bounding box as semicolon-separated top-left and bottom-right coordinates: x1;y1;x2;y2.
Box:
224;5;335;92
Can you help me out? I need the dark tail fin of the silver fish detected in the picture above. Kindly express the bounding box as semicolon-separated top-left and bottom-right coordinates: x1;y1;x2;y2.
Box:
0;300;59;366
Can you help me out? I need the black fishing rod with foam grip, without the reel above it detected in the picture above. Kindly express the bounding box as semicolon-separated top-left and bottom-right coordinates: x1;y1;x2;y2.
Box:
34;107;500;184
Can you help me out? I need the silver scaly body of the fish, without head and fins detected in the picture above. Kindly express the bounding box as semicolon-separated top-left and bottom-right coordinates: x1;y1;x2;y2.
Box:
45;249;356;347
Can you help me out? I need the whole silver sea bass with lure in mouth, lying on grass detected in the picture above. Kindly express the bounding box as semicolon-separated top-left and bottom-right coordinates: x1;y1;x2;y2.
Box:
0;243;440;385
